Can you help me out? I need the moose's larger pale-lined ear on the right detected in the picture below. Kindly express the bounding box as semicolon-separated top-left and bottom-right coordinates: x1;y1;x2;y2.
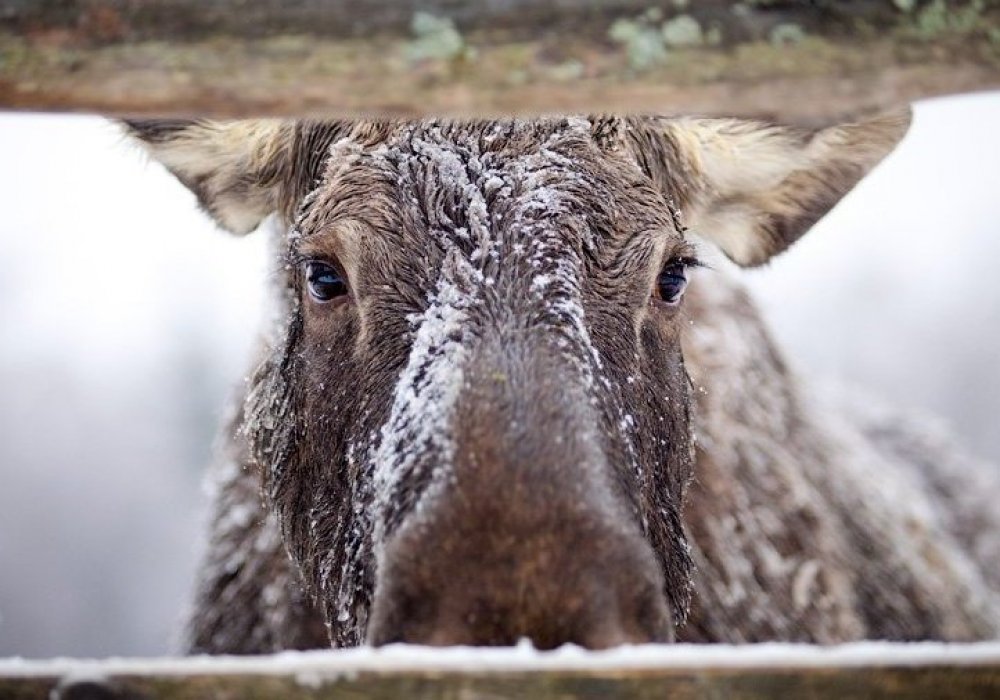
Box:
633;108;911;267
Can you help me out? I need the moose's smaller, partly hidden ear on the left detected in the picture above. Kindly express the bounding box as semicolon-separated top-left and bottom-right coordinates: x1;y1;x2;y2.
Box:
123;119;296;234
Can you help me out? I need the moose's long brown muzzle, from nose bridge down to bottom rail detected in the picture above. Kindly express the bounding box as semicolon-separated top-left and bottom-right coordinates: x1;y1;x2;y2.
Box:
368;345;673;649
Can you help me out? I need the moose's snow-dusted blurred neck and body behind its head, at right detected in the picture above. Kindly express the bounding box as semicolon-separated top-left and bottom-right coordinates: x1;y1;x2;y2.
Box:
682;274;1000;643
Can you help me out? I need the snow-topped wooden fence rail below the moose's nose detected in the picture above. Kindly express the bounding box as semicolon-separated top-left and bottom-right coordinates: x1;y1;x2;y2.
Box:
0;643;1000;700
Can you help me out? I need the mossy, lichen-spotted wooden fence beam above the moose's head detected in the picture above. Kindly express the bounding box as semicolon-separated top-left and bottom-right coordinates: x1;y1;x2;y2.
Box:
0;0;1000;121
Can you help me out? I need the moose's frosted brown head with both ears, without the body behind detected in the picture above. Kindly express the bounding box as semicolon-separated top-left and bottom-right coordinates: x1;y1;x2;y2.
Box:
129;109;908;648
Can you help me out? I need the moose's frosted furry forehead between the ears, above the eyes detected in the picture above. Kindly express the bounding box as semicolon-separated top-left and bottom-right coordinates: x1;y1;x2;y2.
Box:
292;118;681;284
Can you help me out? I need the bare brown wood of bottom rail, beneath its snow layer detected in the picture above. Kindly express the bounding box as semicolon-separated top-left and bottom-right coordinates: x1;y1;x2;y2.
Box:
0;668;1000;700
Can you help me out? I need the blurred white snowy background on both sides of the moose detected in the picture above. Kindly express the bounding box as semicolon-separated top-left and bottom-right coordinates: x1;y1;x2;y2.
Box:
0;93;1000;657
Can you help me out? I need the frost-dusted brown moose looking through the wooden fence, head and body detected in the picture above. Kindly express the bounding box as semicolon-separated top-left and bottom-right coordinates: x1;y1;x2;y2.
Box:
123;109;1000;654
